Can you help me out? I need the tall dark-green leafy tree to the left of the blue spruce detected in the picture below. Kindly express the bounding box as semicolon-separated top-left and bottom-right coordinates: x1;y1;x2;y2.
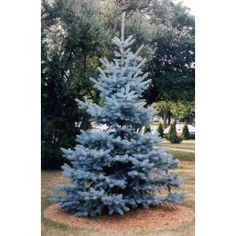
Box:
41;0;109;169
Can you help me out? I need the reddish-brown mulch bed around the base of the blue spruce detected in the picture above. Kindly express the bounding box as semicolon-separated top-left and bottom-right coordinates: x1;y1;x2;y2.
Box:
44;204;194;232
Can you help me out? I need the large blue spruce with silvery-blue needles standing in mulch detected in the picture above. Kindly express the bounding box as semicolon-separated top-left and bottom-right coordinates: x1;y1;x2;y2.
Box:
53;14;183;217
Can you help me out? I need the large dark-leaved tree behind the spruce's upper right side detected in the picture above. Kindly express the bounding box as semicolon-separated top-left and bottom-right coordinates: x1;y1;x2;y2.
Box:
145;0;195;103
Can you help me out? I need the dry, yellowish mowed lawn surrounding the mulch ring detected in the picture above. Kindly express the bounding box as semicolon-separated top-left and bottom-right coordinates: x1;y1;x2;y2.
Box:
41;145;195;236
